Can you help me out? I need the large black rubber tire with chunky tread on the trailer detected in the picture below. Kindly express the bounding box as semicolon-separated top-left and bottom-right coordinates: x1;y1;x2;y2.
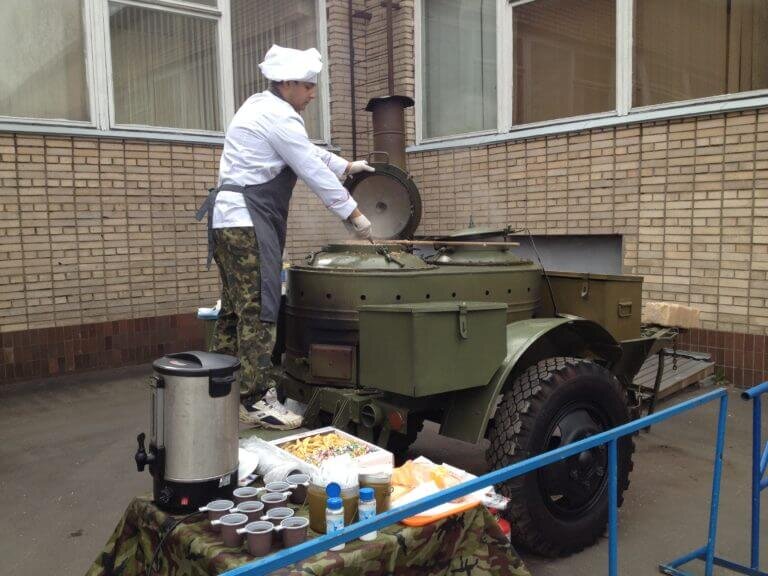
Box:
486;358;634;557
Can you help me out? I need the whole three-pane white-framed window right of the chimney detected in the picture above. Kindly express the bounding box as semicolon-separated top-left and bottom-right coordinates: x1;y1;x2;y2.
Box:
416;0;768;143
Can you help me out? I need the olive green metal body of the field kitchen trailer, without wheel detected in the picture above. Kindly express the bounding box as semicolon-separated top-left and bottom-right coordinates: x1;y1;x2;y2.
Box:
282;242;658;452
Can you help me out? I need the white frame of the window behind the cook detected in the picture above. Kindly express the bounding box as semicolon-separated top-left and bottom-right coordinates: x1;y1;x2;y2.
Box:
0;0;331;145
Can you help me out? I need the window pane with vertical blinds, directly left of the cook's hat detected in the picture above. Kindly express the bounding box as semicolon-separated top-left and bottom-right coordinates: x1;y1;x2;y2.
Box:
109;2;222;130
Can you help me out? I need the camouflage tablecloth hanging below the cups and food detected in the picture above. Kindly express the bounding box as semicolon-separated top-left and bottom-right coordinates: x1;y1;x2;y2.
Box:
86;497;530;576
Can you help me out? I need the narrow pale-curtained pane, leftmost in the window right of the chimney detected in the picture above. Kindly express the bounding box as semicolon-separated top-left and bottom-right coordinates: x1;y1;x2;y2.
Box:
422;0;496;138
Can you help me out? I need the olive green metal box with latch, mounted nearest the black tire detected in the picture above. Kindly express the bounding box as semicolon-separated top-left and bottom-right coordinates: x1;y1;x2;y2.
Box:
359;302;507;397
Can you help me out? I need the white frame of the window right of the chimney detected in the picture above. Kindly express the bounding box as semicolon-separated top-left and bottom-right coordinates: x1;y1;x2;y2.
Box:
408;0;768;146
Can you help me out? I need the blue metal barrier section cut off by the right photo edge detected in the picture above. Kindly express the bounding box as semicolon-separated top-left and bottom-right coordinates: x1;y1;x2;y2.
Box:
659;382;768;576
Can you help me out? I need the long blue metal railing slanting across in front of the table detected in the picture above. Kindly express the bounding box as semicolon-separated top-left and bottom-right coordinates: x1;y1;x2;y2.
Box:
223;388;728;576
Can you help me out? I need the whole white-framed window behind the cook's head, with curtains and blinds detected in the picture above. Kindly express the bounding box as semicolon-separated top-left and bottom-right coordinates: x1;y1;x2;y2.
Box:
0;0;328;140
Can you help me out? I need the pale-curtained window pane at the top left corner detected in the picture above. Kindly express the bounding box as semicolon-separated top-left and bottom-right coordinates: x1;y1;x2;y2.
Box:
0;0;90;120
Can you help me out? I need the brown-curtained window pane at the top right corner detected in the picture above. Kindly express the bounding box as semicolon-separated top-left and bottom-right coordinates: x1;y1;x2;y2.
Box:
632;0;768;106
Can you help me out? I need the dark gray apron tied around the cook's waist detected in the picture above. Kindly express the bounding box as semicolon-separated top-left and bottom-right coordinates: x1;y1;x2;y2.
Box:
196;166;296;322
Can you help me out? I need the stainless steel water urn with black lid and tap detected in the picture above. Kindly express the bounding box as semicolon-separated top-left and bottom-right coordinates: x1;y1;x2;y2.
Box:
135;352;240;512
